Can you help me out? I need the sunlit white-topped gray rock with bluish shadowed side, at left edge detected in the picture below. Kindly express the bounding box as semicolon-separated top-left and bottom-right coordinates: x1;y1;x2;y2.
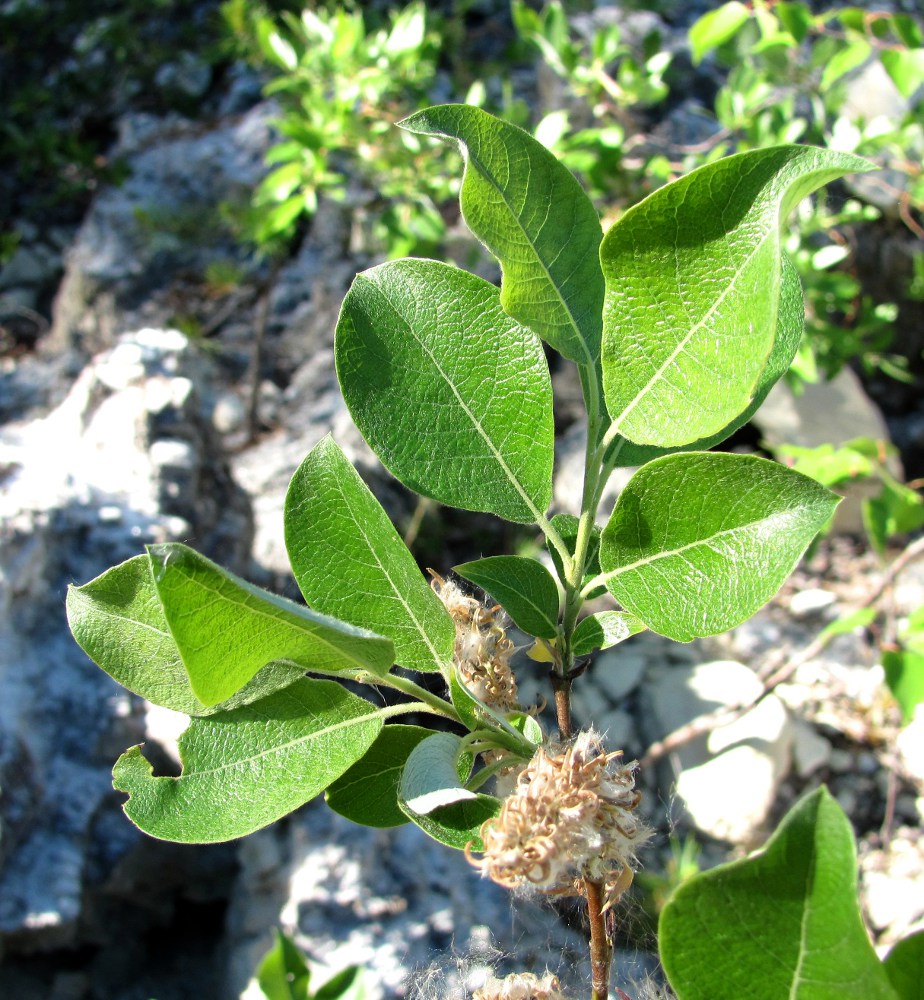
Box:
0;330;252;950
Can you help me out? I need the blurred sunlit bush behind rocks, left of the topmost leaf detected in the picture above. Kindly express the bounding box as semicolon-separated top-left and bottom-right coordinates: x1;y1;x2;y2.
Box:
222;0;470;257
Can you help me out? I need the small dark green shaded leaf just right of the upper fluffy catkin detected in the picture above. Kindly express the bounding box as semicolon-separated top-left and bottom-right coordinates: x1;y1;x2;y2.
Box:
453;556;558;639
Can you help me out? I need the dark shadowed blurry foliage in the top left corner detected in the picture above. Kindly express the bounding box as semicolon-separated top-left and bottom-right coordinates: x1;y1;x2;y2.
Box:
0;0;227;221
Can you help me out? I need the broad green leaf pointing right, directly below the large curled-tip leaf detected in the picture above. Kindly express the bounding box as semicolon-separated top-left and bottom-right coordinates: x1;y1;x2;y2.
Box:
600;452;839;642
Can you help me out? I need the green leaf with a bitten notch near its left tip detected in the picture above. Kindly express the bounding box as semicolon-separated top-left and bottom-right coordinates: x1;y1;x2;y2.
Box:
112;679;382;844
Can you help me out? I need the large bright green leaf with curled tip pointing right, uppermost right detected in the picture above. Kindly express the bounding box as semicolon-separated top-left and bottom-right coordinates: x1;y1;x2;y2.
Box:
600;146;871;447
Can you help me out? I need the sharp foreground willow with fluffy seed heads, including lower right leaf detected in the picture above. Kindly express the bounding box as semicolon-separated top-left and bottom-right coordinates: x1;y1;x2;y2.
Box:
68;105;920;1000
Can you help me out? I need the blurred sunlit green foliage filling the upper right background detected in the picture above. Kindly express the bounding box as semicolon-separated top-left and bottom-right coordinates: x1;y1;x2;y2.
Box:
513;0;924;385
